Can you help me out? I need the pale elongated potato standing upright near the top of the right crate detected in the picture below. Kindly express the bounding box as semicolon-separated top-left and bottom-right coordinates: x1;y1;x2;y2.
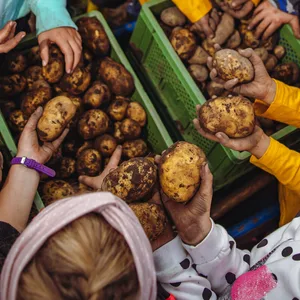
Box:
208;13;234;45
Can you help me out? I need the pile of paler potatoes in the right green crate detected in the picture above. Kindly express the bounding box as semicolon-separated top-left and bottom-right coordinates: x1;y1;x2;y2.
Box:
159;7;299;135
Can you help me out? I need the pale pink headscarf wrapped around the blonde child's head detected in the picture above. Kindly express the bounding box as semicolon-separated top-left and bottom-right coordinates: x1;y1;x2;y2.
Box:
0;192;156;300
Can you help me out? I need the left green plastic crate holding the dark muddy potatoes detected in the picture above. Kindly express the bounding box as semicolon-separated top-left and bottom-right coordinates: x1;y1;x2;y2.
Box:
0;11;173;210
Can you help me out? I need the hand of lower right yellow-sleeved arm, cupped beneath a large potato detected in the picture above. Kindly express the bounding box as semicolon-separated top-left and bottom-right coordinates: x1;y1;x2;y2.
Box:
193;105;270;159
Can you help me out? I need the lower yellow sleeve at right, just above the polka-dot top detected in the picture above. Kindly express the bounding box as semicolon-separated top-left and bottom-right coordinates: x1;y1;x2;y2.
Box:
250;138;300;192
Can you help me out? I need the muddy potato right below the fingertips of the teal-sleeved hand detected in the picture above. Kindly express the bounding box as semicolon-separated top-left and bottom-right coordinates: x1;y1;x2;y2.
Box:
60;67;92;96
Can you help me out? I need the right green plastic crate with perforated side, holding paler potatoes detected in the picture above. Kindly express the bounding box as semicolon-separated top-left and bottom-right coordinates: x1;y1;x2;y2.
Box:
130;0;300;190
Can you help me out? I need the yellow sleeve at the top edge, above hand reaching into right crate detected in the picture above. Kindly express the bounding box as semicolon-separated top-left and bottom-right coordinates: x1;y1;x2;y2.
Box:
173;0;212;23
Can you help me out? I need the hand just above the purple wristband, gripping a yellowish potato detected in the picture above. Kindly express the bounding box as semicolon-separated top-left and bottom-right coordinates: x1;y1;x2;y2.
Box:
17;107;69;164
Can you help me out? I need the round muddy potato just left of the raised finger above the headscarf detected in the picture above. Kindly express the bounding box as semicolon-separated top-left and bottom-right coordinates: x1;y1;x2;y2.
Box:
76;149;102;176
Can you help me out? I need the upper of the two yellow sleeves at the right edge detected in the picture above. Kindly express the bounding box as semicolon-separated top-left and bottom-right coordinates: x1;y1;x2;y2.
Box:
254;80;300;127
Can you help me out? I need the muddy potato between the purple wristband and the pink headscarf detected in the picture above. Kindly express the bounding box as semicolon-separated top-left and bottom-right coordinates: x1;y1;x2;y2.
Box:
42;180;74;204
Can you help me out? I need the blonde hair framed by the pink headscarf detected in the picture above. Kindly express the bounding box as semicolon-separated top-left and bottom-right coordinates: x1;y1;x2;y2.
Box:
18;213;139;300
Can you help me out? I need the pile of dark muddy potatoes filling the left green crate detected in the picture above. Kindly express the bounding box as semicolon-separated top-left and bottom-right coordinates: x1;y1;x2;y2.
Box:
0;17;149;205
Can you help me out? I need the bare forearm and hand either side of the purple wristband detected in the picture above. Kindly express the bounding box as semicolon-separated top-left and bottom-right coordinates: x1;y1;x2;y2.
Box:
0;107;68;232
